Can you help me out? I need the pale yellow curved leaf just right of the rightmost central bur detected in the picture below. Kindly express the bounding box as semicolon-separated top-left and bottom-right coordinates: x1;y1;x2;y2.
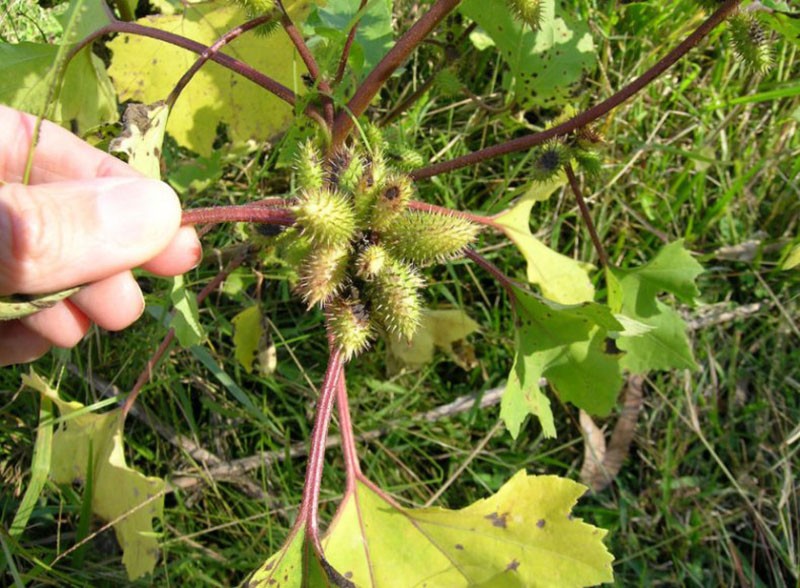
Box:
493;174;594;304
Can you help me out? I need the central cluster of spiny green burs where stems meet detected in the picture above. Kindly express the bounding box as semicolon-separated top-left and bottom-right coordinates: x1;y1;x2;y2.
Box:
293;129;479;359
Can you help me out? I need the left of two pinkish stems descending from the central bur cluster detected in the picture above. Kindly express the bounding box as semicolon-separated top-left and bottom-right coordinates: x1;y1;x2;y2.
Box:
295;347;344;554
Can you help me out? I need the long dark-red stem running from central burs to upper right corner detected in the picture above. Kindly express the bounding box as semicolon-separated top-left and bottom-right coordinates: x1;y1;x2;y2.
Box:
410;0;741;180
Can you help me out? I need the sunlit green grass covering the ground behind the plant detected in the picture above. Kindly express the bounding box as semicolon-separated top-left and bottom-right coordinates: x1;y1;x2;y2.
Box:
0;0;800;587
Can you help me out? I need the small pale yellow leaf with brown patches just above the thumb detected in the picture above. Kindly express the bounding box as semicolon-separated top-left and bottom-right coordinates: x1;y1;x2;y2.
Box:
109;102;169;180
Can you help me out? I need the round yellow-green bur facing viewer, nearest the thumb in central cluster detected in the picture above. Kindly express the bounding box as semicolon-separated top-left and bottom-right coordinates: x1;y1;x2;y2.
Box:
295;188;356;247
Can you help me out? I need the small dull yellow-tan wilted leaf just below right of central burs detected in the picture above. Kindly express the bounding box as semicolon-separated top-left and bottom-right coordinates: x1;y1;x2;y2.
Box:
388;309;480;369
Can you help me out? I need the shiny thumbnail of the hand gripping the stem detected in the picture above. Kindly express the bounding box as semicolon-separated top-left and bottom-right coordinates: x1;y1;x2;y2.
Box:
97;178;181;251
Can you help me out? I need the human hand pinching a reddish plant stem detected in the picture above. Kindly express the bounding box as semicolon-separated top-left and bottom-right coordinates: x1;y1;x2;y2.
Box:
0;106;202;366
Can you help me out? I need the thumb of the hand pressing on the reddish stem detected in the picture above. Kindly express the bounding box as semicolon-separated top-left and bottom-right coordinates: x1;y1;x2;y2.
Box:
0;177;181;295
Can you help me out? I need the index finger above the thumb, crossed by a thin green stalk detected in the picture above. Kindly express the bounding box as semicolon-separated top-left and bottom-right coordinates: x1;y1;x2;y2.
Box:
0;105;141;184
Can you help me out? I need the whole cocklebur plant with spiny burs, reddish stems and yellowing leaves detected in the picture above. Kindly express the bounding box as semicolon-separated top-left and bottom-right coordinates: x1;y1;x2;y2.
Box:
3;0;792;586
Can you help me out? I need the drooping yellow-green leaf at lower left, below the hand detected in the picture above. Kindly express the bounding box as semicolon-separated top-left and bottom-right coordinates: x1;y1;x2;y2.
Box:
22;372;166;580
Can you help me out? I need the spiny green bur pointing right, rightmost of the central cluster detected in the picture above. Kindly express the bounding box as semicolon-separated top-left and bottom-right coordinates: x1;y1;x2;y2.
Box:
384;210;478;265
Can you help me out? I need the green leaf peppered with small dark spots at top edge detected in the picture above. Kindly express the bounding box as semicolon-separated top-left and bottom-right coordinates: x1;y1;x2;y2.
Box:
461;0;596;108
